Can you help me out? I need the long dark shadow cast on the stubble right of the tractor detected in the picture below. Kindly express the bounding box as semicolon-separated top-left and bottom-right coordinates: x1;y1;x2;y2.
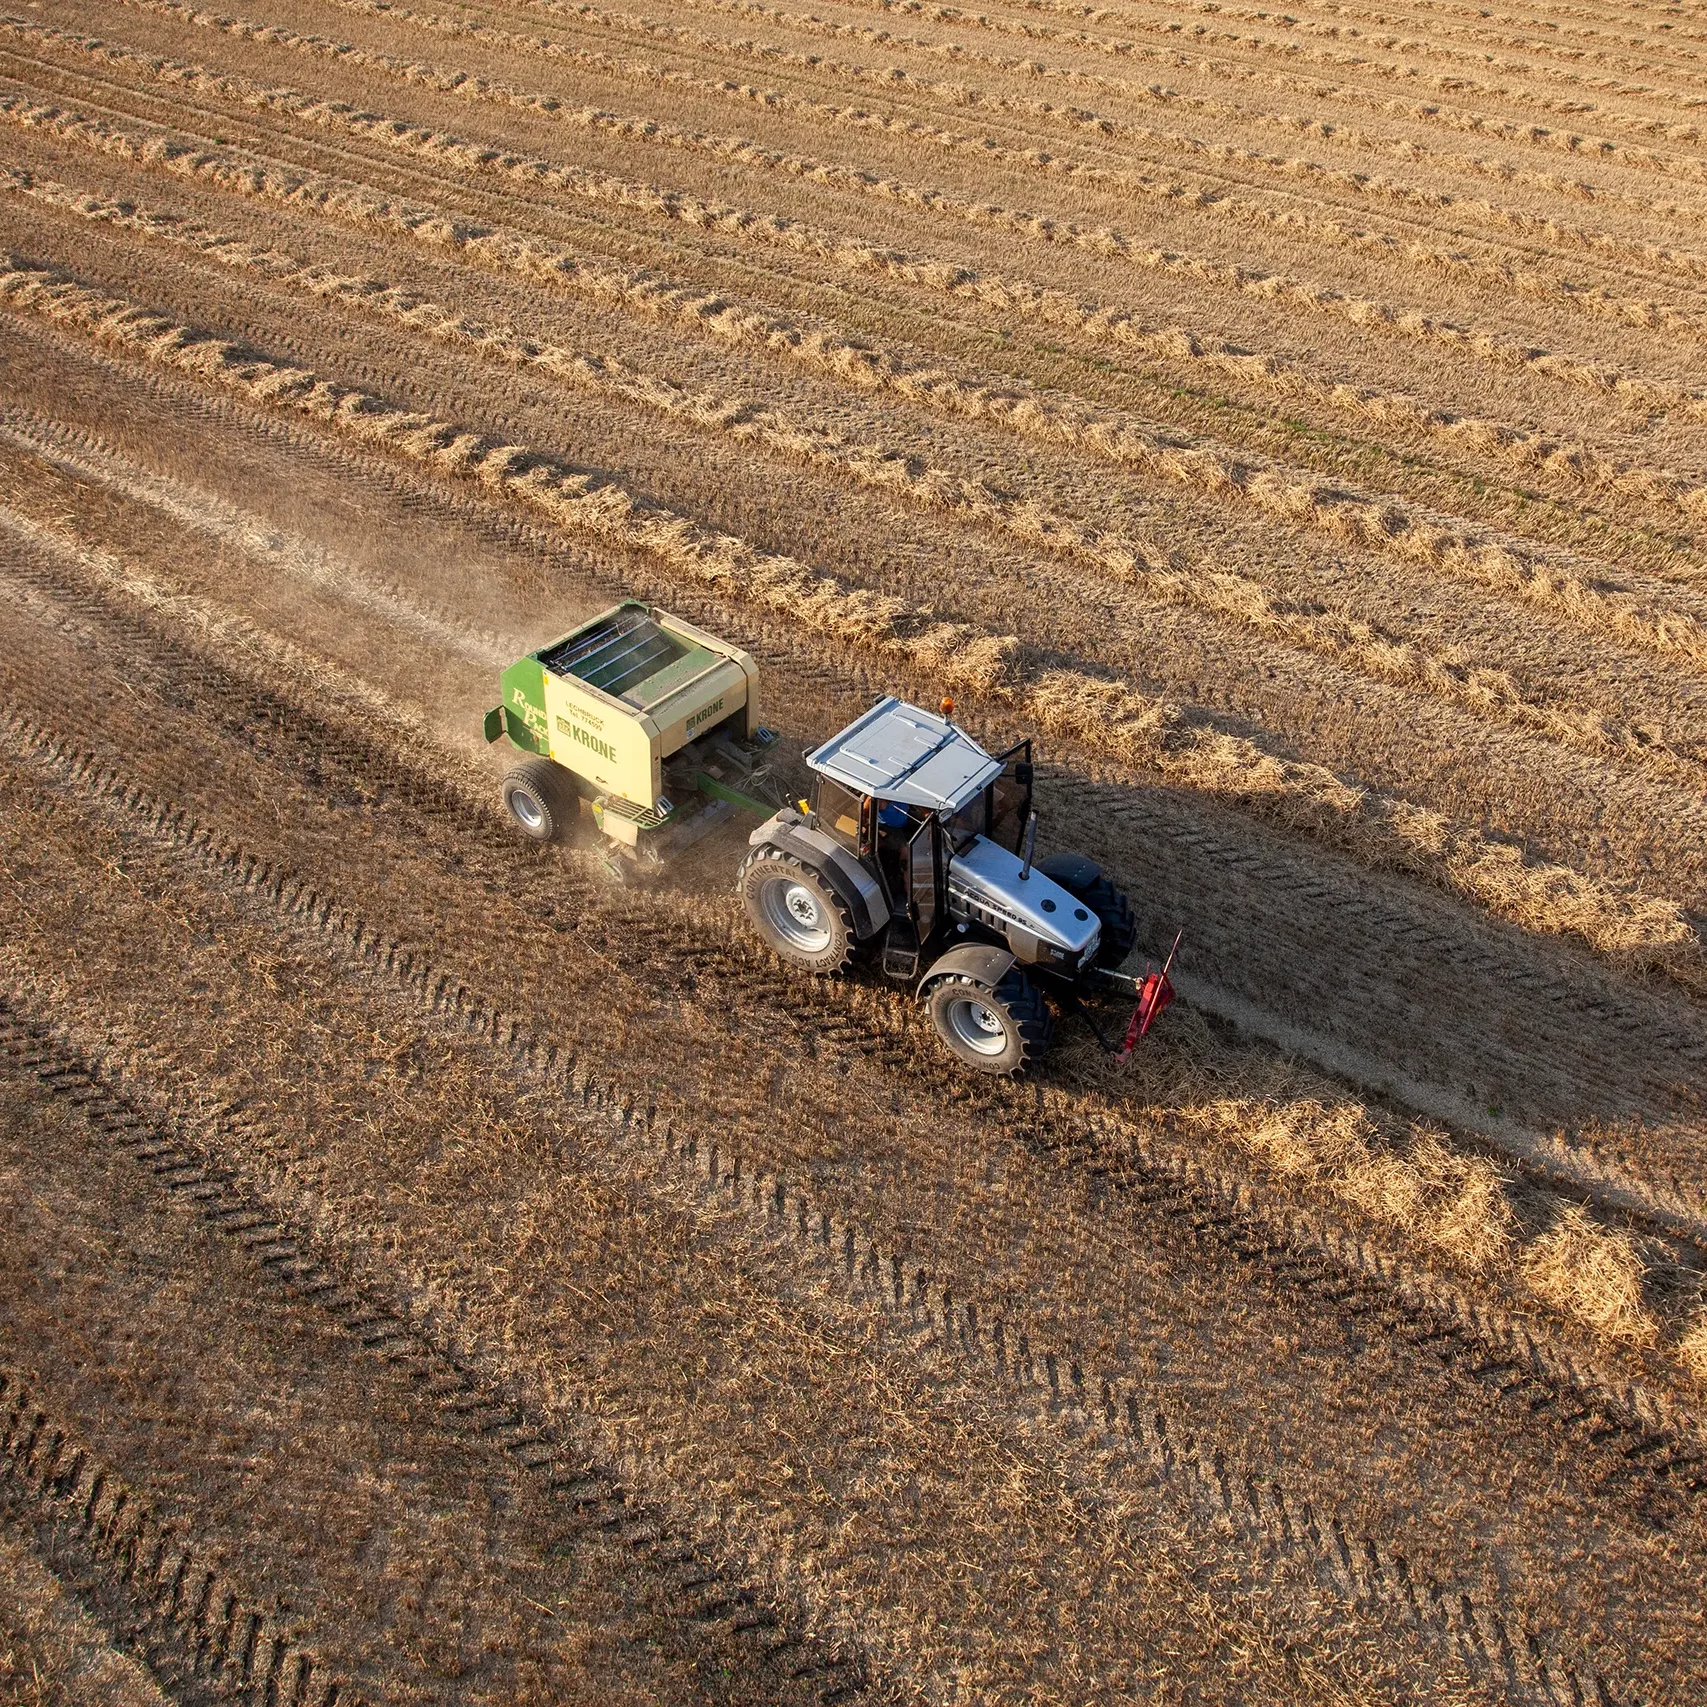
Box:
1038;766;1707;1171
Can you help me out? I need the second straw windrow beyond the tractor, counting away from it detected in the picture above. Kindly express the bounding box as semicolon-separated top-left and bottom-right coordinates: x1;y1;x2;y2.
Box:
10;167;1693;777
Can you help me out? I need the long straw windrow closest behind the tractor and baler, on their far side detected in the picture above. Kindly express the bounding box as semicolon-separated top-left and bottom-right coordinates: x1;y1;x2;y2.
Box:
0;259;1700;976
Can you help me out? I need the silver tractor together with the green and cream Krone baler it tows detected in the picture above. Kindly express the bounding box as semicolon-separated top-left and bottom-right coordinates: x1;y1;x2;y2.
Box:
485;601;1180;1074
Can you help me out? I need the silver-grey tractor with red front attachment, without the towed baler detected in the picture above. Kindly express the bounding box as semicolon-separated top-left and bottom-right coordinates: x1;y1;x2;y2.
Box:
739;698;1171;1072
